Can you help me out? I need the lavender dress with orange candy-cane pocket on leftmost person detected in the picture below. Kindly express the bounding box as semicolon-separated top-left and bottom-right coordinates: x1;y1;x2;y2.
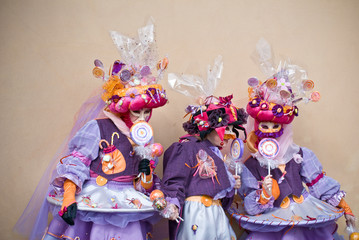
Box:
44;119;159;240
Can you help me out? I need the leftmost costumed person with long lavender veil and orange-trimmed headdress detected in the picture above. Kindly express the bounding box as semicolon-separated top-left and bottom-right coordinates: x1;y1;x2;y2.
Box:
18;20;168;240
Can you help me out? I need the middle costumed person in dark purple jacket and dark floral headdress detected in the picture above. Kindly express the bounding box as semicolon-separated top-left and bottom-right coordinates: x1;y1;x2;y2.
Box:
161;58;247;239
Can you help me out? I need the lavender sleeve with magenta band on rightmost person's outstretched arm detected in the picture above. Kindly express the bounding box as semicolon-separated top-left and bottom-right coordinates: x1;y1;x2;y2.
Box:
300;148;345;206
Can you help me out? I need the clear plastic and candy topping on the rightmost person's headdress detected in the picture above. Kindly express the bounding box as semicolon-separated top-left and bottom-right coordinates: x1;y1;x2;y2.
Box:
249;38;320;106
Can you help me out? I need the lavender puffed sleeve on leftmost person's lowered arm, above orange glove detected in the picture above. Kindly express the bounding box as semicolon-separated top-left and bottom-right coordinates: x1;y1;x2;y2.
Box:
52;120;101;193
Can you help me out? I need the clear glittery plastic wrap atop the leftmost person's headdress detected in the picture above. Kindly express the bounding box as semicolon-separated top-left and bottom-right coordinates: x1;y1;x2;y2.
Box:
110;18;159;81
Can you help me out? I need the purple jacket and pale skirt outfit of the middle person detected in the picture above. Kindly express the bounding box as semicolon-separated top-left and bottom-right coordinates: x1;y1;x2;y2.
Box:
162;137;236;240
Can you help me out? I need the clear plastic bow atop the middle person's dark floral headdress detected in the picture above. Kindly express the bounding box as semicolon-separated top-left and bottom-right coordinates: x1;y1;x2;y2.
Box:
168;56;223;99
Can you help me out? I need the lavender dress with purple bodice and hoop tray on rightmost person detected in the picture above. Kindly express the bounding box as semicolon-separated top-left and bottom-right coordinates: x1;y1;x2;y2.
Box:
229;148;345;240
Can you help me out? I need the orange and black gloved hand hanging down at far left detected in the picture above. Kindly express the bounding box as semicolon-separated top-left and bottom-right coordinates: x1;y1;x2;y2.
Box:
59;179;77;225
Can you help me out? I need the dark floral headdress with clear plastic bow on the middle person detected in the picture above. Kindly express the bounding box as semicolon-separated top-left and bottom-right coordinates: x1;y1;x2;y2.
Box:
168;56;247;140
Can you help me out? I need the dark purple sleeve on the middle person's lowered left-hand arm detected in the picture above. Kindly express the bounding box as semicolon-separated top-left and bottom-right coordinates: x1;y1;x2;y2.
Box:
162;143;191;208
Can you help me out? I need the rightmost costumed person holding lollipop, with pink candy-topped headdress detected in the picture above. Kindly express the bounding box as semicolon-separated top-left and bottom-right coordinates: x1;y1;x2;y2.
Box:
229;40;355;240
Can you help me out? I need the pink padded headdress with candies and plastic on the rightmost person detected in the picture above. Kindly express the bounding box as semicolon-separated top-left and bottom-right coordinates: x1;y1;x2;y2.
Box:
247;39;320;124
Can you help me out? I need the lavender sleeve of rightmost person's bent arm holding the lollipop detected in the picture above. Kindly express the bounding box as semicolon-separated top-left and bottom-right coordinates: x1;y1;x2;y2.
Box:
239;165;274;215
